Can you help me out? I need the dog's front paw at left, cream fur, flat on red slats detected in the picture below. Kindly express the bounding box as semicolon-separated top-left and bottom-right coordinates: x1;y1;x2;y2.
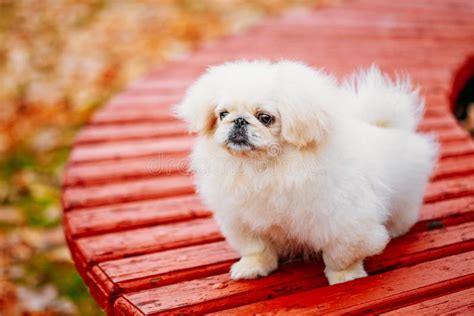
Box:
230;254;278;280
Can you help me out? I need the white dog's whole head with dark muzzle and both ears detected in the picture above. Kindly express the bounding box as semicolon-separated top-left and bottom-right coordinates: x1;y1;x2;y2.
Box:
177;61;333;156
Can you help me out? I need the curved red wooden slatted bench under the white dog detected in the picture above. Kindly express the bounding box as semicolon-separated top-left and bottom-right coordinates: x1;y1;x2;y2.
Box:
62;0;474;315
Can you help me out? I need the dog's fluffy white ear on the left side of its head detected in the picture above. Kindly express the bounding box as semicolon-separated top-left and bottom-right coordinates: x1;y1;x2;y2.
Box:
175;72;216;134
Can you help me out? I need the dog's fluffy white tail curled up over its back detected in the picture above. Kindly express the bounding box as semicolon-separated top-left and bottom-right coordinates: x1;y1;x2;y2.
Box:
345;66;424;131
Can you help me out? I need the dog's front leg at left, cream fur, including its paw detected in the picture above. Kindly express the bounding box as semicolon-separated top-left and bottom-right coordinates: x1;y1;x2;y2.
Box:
222;223;278;280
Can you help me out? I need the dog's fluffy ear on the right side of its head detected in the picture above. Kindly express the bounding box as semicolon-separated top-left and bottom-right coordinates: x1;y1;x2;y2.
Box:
276;61;337;148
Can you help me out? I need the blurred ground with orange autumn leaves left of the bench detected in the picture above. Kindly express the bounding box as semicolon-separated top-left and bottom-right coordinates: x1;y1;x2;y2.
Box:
0;0;323;315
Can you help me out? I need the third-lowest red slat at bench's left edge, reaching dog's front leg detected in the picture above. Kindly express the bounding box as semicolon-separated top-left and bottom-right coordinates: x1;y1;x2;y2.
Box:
76;218;223;266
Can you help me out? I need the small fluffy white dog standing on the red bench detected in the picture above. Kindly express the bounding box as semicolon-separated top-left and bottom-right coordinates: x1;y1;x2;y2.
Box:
177;61;437;284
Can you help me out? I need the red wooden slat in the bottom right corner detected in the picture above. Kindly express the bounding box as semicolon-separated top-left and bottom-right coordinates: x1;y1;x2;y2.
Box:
381;288;474;316
